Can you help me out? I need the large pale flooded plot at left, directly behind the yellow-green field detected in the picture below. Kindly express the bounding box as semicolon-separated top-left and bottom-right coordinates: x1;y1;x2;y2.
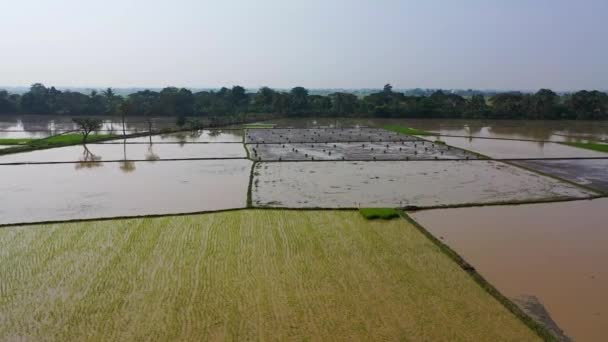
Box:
0;160;251;224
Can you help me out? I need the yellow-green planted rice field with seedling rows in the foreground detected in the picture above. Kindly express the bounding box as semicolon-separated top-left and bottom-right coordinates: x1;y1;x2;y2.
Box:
0;210;539;341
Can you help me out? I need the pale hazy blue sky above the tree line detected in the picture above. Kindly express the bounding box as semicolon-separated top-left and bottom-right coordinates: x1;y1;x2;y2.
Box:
0;0;608;90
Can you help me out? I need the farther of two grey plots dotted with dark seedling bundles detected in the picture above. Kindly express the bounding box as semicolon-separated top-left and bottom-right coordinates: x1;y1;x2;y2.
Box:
245;128;419;144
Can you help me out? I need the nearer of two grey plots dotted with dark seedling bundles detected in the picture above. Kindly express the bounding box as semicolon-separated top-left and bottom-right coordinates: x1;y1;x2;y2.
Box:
246;140;479;161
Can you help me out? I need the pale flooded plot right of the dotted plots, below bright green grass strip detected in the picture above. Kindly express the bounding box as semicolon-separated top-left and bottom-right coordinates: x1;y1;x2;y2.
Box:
441;137;608;159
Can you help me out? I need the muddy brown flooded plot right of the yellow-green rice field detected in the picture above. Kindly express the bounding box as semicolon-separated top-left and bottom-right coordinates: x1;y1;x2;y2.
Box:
412;198;608;341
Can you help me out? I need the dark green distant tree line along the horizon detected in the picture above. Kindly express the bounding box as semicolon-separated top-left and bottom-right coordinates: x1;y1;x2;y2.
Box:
0;83;608;120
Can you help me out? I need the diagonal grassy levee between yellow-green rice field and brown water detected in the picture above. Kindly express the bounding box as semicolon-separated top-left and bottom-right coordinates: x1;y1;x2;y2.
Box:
401;211;558;341
